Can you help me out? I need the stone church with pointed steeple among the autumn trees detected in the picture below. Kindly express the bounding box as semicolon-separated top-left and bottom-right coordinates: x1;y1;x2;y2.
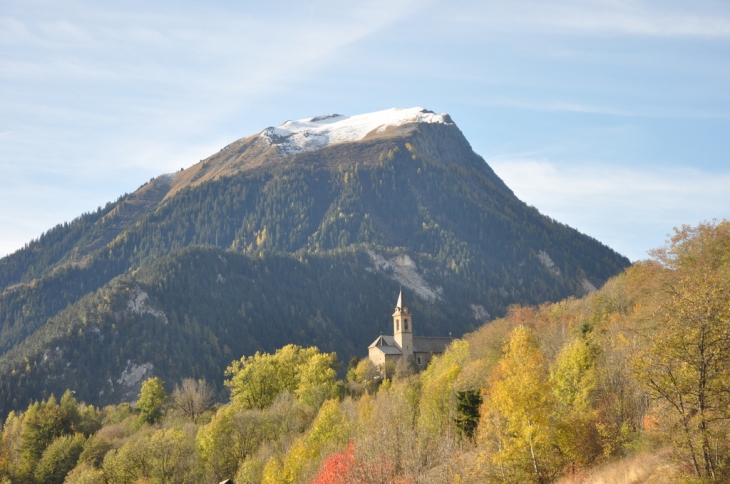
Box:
368;288;452;368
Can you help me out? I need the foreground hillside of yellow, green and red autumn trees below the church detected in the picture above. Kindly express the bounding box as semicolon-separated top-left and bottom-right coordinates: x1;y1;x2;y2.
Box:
0;221;730;484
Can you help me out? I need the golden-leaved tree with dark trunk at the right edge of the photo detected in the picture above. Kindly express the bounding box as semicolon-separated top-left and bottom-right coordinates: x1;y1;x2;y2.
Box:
633;271;730;480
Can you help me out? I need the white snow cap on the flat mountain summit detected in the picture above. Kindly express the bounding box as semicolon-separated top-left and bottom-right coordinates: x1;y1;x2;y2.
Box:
259;107;453;155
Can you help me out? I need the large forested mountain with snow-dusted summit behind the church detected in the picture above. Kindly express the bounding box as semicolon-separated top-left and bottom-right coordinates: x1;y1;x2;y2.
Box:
0;108;629;413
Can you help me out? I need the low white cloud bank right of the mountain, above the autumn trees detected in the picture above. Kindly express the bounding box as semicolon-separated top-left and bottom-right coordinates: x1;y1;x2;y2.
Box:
487;156;730;260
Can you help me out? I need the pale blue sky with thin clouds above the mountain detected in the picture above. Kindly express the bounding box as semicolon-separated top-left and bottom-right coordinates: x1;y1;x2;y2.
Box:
0;0;730;260
